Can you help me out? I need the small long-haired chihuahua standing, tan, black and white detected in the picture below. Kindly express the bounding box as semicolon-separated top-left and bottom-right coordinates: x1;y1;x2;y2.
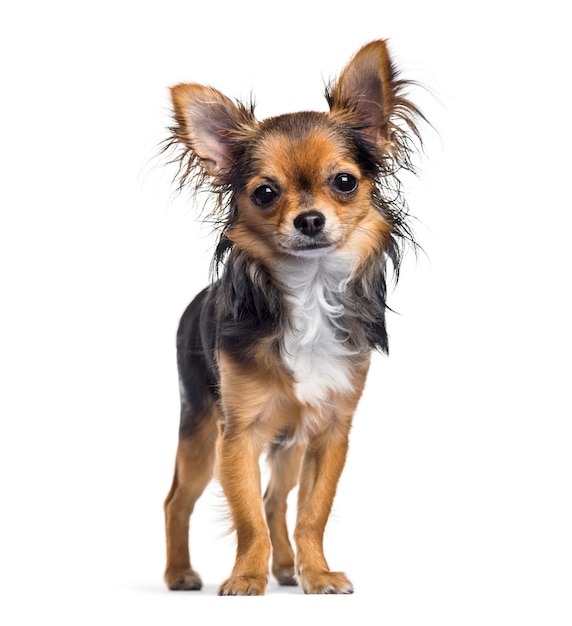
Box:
164;40;423;595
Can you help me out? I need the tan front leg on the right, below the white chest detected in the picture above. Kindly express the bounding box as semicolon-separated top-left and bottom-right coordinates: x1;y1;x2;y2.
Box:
294;418;353;593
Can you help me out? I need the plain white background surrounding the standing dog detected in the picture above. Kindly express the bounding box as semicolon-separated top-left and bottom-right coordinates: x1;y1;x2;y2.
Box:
0;0;572;626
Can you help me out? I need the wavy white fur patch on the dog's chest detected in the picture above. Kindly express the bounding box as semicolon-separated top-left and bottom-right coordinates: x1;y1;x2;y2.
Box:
278;253;353;406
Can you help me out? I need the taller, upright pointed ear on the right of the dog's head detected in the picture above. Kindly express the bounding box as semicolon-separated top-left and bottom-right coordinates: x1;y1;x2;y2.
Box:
326;40;401;151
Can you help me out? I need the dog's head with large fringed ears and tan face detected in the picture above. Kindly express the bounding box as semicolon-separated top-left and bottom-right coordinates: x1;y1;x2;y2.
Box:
164;41;420;272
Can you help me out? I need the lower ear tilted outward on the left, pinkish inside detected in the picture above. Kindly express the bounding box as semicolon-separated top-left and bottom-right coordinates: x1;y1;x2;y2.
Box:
171;83;254;176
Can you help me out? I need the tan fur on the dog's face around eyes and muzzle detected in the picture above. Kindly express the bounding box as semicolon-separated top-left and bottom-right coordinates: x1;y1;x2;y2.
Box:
228;129;390;263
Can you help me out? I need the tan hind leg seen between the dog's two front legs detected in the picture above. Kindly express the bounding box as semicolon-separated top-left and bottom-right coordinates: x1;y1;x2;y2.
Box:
264;444;305;585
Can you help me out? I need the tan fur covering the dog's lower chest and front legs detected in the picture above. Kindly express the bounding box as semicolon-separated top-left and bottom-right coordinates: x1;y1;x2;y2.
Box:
213;354;368;595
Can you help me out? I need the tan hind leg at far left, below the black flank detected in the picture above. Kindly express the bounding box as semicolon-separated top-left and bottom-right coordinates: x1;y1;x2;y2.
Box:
165;405;218;590
